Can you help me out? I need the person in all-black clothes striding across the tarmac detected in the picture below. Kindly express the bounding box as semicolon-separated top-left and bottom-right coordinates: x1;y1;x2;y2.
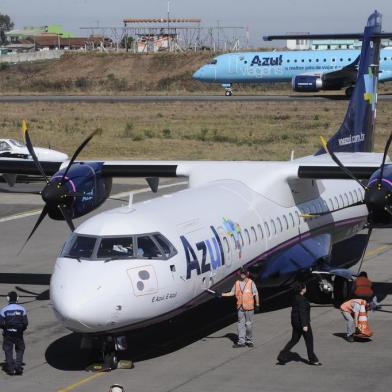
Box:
278;283;321;366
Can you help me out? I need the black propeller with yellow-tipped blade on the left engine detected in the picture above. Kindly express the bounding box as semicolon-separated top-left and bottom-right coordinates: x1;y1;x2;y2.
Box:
18;120;98;254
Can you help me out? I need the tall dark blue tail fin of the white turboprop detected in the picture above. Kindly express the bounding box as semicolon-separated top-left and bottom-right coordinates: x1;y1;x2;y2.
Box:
316;11;387;155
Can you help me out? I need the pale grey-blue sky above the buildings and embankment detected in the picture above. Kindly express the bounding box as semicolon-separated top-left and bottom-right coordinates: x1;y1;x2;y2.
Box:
0;0;392;46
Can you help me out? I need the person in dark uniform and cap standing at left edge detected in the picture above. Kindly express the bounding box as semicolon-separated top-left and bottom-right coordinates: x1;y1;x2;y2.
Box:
0;291;28;376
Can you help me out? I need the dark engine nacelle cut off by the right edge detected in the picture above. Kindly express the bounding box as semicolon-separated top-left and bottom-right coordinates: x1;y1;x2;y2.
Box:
364;165;392;227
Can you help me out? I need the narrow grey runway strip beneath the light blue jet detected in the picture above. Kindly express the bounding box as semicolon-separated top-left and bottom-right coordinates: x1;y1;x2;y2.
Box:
0;93;392;103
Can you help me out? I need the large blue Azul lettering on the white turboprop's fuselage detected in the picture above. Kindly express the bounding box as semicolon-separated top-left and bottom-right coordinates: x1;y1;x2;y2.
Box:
180;226;225;279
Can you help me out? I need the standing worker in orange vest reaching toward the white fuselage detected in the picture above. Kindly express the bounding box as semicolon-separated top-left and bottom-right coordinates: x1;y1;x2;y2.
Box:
222;267;260;348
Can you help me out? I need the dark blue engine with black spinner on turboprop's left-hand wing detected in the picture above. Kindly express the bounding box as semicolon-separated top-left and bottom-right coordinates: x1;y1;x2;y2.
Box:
42;162;112;220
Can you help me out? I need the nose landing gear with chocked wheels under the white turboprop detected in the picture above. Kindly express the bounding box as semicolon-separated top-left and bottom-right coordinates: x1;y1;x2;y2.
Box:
81;335;134;372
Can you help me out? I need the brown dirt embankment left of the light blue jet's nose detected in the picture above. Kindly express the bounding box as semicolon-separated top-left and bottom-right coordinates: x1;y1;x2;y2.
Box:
0;53;288;94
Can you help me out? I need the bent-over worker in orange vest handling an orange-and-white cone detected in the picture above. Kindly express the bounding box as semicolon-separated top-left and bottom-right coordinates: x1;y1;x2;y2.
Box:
340;299;373;343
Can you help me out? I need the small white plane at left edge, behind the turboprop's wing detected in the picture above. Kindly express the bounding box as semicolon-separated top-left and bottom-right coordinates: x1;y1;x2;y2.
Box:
0;139;68;187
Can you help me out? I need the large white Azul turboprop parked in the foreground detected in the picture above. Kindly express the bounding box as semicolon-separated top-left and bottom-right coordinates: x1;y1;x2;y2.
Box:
0;12;392;367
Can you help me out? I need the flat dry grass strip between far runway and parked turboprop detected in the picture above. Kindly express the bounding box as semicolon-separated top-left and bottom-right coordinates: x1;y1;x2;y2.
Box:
0;100;392;160
